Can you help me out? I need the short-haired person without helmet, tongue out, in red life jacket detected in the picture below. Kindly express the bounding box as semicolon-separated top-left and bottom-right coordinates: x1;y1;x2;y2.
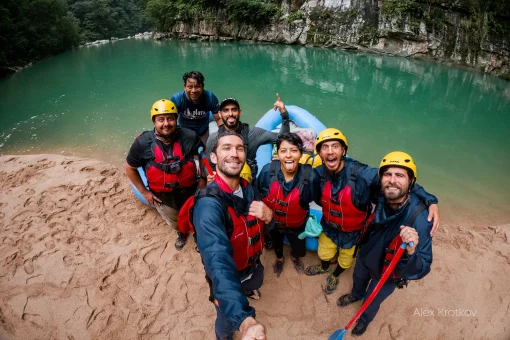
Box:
255;132;312;277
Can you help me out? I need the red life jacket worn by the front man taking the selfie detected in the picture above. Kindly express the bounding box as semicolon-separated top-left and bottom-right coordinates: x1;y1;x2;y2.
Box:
177;176;264;271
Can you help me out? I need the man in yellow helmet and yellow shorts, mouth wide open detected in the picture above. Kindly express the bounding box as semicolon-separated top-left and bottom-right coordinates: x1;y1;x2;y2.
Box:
305;128;439;294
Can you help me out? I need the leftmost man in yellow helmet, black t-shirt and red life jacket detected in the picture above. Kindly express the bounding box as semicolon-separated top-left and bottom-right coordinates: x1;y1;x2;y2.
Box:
125;99;205;250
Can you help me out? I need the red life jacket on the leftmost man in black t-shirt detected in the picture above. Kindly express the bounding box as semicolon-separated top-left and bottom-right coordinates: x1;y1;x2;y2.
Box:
145;134;197;192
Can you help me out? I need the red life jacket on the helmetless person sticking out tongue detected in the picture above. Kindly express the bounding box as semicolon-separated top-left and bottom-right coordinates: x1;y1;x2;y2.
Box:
262;160;312;228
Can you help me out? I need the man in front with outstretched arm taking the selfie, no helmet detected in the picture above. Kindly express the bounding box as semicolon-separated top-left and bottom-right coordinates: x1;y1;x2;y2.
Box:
193;131;273;340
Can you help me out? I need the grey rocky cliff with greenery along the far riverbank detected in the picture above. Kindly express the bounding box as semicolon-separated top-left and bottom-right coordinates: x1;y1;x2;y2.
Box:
156;0;510;79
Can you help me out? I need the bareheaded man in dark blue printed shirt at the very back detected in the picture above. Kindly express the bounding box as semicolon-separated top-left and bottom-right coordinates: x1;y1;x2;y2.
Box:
170;71;222;144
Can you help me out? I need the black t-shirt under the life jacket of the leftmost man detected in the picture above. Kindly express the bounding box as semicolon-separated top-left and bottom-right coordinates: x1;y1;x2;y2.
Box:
126;127;203;209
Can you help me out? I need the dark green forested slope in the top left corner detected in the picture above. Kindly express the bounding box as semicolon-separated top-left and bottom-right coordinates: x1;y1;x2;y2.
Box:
0;0;152;68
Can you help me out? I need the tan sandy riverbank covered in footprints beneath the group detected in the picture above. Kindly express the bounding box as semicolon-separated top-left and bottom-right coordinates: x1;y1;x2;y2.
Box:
0;155;510;340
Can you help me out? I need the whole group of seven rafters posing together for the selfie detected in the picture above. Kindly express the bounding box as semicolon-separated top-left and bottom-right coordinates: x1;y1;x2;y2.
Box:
126;71;439;340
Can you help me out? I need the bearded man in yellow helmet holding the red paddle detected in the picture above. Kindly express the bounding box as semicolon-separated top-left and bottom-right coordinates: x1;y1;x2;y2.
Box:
337;151;432;336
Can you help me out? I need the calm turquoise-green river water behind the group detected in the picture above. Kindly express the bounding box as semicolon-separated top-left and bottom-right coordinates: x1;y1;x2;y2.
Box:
0;39;510;225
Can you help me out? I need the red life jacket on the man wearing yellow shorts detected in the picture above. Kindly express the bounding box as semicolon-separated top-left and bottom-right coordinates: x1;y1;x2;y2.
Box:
321;164;373;233
